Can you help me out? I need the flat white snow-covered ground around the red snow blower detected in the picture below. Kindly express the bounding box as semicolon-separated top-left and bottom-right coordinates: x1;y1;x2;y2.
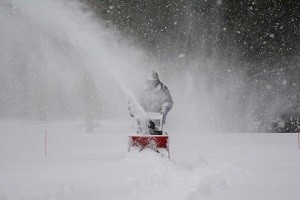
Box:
0;121;300;200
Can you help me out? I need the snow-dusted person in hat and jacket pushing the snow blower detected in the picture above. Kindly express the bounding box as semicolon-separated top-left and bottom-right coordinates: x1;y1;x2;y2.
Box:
128;71;173;132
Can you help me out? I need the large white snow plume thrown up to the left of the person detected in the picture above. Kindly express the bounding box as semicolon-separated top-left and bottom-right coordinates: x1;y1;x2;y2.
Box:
0;0;147;119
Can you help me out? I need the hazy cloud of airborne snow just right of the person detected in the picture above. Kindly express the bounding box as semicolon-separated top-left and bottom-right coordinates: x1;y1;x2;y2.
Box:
157;58;254;133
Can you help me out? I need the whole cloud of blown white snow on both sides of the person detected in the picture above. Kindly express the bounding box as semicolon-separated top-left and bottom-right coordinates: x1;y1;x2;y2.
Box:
0;0;284;132
